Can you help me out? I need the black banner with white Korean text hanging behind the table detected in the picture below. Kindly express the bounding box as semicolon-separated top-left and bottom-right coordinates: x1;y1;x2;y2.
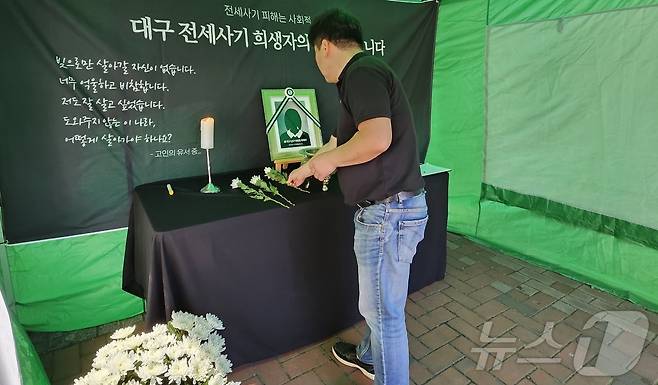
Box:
0;0;438;243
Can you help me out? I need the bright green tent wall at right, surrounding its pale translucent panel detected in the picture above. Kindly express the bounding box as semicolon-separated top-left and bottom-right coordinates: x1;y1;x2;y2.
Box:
428;0;658;310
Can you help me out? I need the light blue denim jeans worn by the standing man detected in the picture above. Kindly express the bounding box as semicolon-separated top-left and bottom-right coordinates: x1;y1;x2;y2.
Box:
354;193;428;385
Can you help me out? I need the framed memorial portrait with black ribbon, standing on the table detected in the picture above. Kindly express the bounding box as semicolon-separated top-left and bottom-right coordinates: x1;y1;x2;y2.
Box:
261;88;323;161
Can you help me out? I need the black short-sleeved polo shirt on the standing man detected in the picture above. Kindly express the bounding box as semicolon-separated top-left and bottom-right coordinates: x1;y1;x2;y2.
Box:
334;52;425;204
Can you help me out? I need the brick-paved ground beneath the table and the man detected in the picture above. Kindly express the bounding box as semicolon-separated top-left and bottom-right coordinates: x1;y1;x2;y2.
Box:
31;234;658;385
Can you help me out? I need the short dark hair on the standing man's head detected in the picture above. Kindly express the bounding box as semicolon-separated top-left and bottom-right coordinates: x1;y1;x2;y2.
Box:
308;9;363;49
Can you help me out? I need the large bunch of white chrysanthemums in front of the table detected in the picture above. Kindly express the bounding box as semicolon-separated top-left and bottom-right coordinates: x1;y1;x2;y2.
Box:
74;312;239;385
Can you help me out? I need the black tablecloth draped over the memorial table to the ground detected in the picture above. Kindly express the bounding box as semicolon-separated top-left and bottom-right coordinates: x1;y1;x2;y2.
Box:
123;170;448;365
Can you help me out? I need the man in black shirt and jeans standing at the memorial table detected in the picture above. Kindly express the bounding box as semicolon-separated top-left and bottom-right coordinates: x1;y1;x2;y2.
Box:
289;10;428;385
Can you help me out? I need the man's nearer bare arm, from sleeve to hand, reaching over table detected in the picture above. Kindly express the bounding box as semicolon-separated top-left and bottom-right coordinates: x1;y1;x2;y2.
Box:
288;118;393;186
